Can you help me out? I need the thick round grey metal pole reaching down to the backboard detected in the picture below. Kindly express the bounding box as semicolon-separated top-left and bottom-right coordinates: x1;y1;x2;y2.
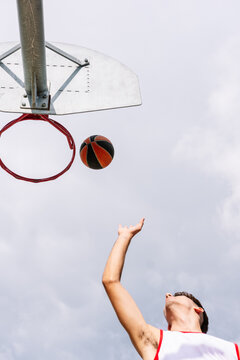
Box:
17;0;47;95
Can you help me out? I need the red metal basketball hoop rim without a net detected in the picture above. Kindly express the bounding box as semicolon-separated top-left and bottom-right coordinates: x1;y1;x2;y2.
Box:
0;114;76;183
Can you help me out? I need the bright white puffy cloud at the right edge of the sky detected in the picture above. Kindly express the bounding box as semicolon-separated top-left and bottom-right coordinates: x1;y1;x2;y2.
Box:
173;38;240;236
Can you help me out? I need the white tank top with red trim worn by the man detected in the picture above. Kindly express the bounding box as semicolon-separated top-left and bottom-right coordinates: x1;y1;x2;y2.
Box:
154;330;240;360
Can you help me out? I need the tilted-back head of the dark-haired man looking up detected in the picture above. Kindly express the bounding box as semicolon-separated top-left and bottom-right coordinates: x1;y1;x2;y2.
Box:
164;291;208;333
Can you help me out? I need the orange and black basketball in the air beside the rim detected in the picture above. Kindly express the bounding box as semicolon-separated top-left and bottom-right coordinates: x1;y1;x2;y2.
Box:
80;135;114;170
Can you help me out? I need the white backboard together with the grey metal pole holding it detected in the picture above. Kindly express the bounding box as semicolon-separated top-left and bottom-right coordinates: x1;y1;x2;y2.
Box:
0;0;141;115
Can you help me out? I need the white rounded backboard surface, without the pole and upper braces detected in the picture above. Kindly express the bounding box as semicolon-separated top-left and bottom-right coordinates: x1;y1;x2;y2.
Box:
0;42;141;115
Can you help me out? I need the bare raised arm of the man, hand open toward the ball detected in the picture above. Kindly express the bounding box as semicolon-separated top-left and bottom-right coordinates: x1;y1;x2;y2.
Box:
102;219;158;358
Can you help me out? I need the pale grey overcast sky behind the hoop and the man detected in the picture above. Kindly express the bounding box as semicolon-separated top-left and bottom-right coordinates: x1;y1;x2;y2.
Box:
0;0;240;360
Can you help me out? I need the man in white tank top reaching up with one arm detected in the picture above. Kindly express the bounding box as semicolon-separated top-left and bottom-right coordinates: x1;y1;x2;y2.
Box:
103;219;240;360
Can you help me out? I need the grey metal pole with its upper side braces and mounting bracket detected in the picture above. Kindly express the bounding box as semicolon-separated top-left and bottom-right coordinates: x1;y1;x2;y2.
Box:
15;0;89;110
